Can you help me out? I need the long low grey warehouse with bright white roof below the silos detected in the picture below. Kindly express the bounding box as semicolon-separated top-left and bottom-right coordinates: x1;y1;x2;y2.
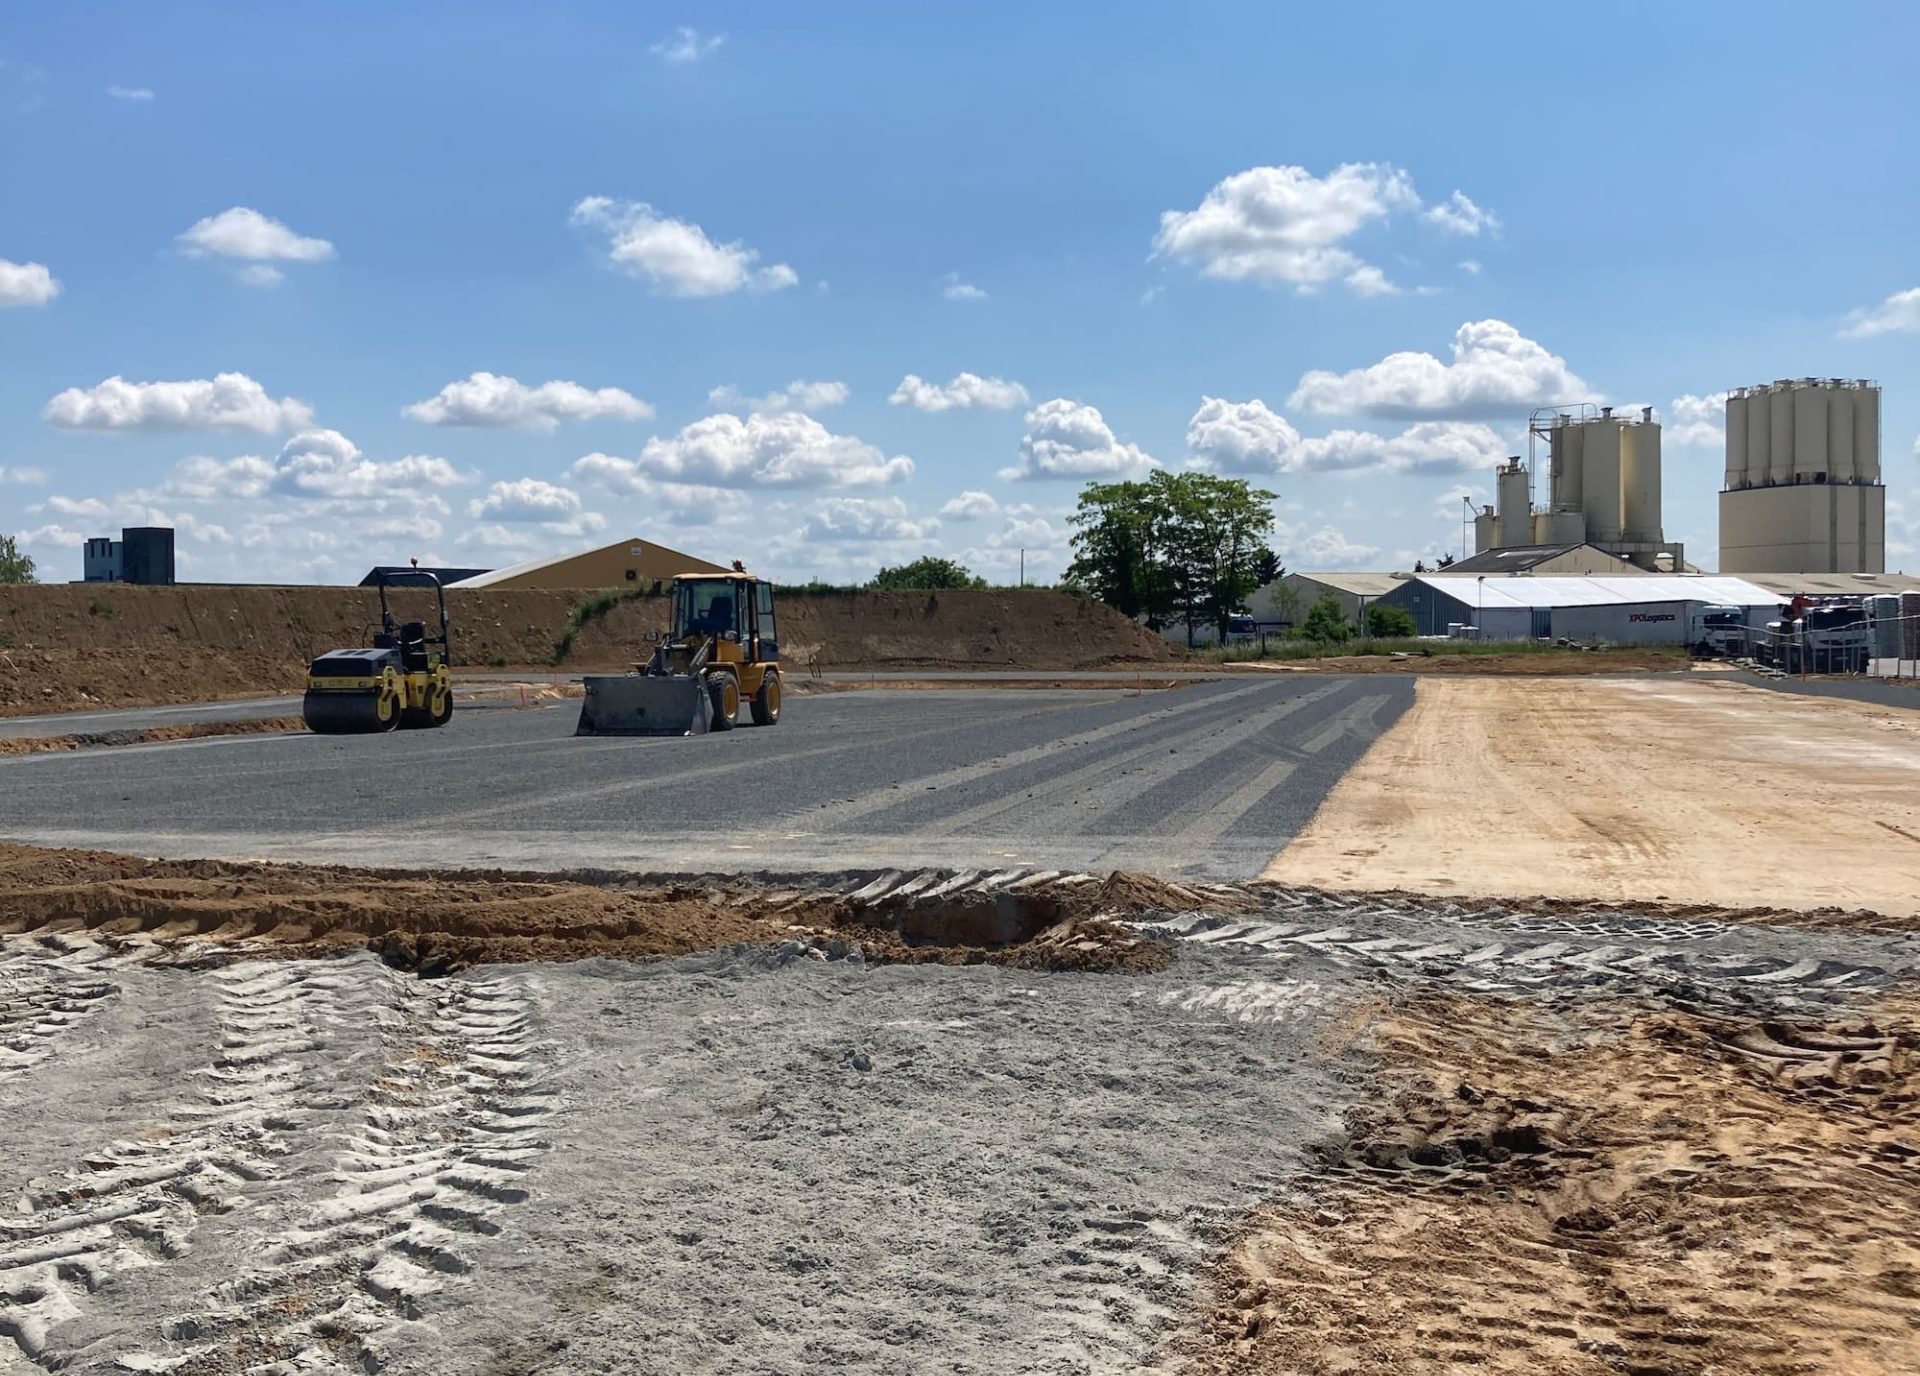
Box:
1379;574;1786;645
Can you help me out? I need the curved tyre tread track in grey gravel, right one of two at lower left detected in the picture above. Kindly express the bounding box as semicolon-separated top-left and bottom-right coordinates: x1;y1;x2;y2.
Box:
134;973;555;1376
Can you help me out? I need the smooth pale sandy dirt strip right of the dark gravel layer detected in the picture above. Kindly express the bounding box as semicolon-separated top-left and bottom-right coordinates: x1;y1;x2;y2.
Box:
1265;676;1920;915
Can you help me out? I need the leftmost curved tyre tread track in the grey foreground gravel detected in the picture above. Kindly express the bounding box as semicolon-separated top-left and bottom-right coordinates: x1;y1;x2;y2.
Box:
0;965;342;1370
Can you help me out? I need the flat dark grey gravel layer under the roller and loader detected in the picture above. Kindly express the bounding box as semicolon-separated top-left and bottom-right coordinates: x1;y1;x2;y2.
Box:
0;676;1413;877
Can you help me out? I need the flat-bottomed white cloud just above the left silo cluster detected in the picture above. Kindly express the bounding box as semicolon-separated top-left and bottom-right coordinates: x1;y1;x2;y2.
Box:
1286;320;1596;418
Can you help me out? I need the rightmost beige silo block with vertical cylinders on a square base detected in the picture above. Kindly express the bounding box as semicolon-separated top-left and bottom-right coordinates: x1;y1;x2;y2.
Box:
1720;378;1887;574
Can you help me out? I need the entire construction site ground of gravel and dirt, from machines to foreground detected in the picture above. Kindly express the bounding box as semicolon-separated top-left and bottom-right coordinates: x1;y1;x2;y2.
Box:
0;674;1920;1376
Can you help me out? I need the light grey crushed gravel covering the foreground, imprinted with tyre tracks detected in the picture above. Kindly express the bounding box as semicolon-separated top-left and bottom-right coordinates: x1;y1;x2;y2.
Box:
0;852;1920;1376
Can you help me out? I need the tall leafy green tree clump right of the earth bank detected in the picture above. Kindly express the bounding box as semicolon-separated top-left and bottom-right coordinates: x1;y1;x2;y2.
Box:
1068;472;1273;645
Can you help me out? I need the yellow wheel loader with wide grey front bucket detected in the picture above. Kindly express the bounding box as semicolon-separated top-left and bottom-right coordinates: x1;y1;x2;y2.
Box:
574;562;780;735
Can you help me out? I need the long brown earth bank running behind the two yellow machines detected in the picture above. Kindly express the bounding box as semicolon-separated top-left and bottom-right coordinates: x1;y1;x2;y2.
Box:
0;583;1175;714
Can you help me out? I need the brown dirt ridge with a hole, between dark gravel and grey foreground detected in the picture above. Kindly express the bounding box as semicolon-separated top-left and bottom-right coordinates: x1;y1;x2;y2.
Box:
0;844;1169;975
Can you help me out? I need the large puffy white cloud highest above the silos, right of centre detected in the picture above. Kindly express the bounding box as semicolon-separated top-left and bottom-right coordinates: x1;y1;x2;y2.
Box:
1154;163;1421;294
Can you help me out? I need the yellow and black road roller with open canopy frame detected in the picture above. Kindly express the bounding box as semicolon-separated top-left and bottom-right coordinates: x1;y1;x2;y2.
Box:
300;572;453;735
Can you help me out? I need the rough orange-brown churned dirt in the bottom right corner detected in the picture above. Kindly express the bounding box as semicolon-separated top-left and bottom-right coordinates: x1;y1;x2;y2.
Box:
1175;992;1920;1376
